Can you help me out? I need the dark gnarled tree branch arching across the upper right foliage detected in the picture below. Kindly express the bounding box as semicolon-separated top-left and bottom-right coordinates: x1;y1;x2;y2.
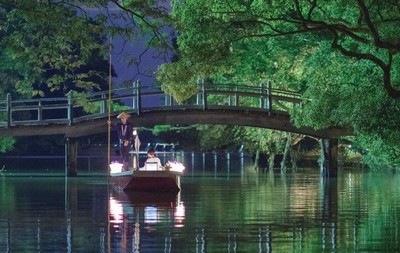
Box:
217;0;400;98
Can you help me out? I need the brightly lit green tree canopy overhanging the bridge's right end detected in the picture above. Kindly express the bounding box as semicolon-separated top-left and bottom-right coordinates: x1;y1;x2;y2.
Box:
158;0;400;169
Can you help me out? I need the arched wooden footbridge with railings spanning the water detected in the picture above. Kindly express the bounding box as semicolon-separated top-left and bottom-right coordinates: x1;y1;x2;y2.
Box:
0;81;348;176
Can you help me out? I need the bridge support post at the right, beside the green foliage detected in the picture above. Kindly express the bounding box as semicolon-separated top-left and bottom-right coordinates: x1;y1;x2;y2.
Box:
320;139;339;178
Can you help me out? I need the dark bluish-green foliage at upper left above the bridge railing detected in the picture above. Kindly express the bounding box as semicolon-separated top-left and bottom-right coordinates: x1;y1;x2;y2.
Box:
0;1;106;97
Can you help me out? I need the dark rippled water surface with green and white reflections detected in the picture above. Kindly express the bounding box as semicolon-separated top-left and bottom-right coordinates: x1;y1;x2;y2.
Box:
0;169;400;252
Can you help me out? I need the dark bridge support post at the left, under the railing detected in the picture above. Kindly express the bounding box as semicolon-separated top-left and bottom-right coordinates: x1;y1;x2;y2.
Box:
64;137;79;177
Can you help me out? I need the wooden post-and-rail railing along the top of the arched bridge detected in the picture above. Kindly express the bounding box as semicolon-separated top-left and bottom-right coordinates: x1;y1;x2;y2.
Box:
0;82;301;127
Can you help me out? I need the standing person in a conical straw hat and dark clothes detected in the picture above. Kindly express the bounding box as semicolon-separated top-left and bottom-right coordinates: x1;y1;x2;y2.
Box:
113;112;133;170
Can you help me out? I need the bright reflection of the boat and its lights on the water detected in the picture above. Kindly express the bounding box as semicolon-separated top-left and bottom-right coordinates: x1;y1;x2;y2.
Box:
109;192;186;252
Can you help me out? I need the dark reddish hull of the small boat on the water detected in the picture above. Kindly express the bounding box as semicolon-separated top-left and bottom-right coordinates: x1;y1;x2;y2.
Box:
110;170;182;192
